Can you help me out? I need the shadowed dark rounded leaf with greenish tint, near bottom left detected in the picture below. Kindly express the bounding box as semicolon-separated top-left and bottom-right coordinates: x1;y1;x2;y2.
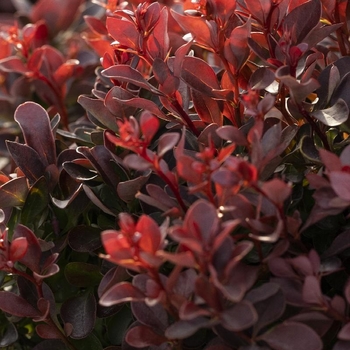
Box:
61;293;96;339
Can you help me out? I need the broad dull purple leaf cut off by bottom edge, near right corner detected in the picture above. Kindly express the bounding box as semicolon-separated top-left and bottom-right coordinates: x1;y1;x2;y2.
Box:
260;322;323;350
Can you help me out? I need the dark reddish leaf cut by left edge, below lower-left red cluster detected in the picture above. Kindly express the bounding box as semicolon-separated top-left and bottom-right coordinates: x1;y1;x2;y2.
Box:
0;291;40;318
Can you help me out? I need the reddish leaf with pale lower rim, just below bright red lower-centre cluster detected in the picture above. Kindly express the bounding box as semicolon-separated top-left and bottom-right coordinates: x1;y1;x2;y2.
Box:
100;282;145;306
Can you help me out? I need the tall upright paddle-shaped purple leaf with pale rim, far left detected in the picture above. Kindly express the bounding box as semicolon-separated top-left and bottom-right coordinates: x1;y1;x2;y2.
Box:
14;102;56;166
